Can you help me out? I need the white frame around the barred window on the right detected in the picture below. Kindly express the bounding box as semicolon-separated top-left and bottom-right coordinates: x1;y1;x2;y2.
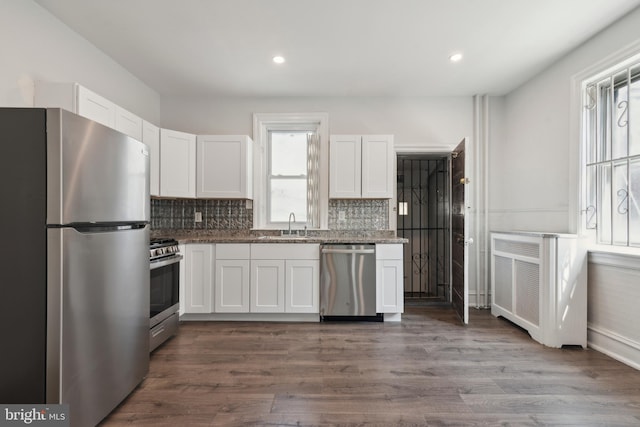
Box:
569;41;640;255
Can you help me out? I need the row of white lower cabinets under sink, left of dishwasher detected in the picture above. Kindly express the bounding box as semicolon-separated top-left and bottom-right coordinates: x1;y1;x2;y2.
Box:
181;243;320;320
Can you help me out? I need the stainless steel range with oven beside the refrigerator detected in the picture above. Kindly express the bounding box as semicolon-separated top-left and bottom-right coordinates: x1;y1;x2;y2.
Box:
149;239;182;352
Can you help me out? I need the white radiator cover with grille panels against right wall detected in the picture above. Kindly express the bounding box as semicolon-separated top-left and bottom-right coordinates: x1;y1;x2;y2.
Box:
491;232;587;348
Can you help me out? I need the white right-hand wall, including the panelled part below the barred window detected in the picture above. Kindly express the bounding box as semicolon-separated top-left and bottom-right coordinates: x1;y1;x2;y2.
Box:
489;9;640;368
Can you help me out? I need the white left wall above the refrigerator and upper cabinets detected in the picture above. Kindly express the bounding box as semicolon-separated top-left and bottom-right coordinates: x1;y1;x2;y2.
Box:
0;0;160;124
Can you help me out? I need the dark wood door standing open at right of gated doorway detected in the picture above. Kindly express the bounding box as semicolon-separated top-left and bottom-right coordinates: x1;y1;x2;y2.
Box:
451;139;469;324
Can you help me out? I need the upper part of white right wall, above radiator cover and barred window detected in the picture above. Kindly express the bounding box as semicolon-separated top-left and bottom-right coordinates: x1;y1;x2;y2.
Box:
490;9;640;232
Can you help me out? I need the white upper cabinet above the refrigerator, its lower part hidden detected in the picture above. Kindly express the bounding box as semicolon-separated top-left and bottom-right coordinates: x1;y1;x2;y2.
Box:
35;81;142;141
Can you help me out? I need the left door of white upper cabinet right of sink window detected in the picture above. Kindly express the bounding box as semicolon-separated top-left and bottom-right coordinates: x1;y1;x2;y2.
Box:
329;135;362;199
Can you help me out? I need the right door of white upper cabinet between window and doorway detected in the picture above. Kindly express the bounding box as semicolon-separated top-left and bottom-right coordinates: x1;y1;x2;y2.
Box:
362;135;395;199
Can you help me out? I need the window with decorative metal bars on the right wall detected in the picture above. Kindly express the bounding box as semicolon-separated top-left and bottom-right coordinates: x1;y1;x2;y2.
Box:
582;60;640;247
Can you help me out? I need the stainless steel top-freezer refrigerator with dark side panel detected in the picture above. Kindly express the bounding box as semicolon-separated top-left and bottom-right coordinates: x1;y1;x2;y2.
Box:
0;108;150;427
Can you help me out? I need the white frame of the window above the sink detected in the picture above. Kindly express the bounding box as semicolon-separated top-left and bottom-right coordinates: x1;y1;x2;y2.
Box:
253;113;329;230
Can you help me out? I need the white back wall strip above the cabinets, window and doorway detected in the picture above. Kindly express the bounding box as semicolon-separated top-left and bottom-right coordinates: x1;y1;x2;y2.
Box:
162;97;473;151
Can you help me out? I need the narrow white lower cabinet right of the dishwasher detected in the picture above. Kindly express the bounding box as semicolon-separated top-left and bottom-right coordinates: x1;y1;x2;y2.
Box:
376;244;404;313
